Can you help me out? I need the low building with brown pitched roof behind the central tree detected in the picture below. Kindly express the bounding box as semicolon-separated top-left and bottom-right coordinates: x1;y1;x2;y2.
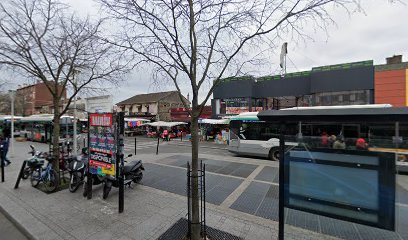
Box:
116;91;188;121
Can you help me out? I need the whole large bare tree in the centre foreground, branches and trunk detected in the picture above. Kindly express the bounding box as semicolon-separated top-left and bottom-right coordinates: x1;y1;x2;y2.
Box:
99;0;359;239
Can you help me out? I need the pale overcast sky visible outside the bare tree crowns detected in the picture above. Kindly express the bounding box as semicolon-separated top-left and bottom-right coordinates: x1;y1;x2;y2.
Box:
8;0;408;104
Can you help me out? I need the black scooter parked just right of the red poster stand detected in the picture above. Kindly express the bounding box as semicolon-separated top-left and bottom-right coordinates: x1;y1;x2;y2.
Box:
102;154;145;199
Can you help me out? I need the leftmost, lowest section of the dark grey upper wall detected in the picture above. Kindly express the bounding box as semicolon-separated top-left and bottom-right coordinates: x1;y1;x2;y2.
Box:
213;80;255;98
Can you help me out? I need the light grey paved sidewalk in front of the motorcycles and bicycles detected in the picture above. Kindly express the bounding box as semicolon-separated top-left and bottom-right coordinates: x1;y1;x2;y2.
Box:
0;142;335;240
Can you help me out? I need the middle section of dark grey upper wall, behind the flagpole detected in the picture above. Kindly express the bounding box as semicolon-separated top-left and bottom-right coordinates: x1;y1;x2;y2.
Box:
253;77;310;97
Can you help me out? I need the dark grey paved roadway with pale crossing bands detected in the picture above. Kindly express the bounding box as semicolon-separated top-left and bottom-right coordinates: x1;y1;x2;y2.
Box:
143;154;408;240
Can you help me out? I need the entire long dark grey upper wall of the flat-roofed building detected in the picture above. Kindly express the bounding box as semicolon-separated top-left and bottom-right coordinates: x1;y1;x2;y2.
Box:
213;66;374;99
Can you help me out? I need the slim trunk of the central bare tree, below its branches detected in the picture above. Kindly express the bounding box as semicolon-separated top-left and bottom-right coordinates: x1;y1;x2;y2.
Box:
190;109;201;240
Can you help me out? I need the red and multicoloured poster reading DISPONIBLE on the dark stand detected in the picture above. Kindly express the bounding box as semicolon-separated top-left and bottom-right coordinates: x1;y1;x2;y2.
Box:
89;113;116;177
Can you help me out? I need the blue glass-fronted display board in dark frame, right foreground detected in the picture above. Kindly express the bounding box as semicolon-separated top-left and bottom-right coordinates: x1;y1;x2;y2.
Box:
284;148;395;230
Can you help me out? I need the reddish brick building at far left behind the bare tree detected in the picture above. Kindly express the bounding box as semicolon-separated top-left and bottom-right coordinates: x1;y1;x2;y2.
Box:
15;82;67;116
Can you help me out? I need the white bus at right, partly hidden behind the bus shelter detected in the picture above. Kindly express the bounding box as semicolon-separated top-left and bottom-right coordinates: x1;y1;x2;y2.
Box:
228;104;408;165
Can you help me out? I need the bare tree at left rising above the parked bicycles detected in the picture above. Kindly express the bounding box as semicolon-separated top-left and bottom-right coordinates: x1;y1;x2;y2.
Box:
0;0;126;176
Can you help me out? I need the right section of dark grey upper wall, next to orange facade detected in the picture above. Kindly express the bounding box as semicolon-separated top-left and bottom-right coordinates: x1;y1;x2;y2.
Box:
310;66;374;93
